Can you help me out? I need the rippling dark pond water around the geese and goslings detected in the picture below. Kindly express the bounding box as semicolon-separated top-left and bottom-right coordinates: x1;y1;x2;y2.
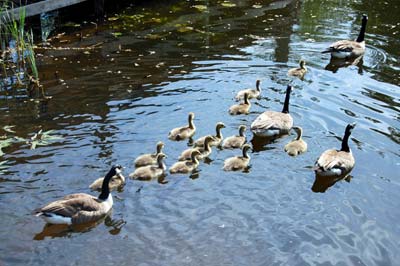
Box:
0;0;400;265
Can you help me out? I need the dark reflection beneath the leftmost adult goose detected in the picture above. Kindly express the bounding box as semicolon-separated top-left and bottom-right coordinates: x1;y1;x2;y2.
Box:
33;216;126;240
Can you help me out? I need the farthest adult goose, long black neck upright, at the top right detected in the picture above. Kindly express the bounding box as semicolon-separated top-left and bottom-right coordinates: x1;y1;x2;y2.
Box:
322;15;368;58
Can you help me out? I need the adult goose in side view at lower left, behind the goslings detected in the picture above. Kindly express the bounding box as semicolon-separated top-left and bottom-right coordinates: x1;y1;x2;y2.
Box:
34;165;122;224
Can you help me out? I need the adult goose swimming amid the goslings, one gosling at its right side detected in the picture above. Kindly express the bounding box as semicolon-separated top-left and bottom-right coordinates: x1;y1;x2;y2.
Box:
251;85;293;137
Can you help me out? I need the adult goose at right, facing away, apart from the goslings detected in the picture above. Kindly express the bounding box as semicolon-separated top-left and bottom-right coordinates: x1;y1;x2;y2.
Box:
313;123;356;178
